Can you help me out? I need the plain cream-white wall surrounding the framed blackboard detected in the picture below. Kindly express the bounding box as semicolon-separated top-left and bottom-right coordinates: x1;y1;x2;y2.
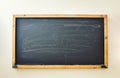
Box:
0;0;120;78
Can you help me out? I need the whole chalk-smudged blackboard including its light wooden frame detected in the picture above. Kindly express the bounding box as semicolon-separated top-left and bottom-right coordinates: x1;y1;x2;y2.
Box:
13;15;107;68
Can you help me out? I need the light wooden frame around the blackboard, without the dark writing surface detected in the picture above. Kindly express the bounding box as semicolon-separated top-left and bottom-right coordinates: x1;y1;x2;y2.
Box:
12;14;108;69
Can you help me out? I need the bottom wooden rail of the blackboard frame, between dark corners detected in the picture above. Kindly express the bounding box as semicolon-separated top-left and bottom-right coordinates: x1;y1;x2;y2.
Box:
17;65;101;69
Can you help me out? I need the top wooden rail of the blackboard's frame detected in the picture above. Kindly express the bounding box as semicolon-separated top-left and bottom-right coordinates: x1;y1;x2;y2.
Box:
14;14;104;18
